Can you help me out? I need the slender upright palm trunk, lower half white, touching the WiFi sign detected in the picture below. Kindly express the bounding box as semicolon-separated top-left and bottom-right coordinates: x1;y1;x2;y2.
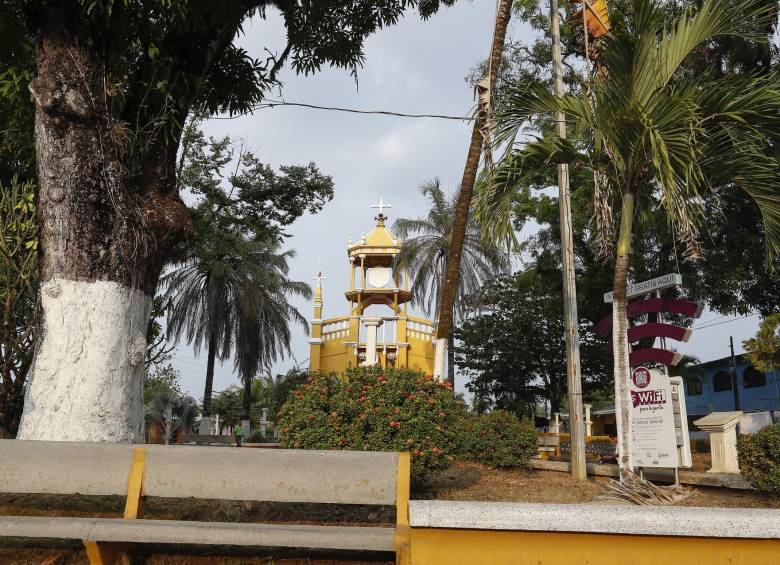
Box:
612;192;634;480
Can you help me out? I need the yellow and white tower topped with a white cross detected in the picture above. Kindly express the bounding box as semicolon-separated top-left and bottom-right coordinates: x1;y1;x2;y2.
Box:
309;198;436;375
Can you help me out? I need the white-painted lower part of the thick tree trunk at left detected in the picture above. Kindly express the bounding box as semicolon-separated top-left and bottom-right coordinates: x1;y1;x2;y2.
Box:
17;279;152;443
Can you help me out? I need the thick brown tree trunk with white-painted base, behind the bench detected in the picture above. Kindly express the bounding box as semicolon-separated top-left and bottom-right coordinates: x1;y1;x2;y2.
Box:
18;6;187;442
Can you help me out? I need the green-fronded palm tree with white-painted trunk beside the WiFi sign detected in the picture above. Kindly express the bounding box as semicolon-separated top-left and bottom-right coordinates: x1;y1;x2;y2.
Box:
477;0;780;479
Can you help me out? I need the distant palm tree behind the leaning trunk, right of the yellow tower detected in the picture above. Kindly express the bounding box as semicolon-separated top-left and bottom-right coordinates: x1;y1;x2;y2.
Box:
393;179;509;387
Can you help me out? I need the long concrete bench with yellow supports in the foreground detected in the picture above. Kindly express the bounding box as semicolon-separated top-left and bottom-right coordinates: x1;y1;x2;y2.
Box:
0;440;410;565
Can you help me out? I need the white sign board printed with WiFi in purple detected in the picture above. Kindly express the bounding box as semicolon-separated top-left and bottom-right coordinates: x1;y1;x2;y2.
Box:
628;367;677;467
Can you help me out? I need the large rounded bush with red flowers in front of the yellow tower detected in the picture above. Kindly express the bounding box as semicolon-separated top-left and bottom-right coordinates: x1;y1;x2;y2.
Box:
278;368;465;478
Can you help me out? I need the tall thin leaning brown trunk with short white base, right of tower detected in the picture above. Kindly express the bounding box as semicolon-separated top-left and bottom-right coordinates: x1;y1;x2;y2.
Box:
434;0;512;378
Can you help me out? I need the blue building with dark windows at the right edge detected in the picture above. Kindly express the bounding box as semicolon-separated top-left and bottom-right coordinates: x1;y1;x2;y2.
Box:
685;355;780;419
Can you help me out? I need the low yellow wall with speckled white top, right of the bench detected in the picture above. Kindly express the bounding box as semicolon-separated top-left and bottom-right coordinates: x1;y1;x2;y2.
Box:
409;501;780;565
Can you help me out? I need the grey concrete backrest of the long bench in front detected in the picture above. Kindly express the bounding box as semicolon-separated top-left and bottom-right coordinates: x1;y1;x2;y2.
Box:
0;440;398;505
